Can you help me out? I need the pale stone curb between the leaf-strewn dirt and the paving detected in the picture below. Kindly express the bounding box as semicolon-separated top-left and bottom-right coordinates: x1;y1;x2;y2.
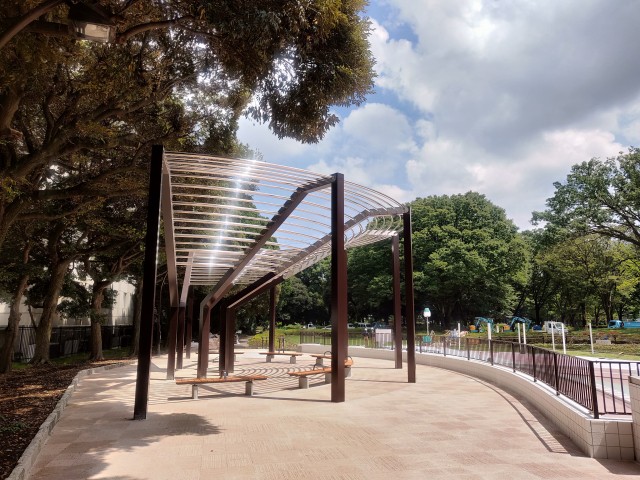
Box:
7;363;130;480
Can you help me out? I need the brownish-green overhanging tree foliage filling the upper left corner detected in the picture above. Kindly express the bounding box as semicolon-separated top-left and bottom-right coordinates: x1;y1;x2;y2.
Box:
0;0;373;253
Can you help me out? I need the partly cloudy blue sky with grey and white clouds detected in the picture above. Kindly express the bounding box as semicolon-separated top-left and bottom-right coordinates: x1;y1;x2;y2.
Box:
238;0;640;230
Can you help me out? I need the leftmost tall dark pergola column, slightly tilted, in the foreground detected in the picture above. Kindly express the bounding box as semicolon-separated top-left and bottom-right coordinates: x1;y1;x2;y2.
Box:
133;145;164;420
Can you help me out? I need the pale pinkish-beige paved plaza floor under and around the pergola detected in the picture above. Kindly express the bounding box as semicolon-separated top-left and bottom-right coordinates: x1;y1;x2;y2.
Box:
29;350;640;480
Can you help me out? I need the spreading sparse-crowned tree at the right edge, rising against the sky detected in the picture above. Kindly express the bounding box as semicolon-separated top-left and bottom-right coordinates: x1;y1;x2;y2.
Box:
533;148;640;247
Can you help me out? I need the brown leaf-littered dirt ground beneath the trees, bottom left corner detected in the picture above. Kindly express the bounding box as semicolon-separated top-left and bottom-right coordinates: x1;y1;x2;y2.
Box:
0;360;131;479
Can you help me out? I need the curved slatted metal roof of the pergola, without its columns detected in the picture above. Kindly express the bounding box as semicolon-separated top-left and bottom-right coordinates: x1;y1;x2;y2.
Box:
162;152;407;300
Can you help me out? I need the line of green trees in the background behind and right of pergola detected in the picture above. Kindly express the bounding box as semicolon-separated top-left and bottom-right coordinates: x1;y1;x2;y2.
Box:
278;148;640;329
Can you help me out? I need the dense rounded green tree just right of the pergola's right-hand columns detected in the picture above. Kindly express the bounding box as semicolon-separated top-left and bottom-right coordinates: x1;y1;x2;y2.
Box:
411;192;527;327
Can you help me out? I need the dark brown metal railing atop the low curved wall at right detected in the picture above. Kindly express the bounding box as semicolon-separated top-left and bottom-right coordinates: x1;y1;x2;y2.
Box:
416;336;640;418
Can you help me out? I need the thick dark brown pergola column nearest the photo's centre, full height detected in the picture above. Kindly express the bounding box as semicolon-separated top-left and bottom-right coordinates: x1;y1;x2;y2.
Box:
331;173;348;403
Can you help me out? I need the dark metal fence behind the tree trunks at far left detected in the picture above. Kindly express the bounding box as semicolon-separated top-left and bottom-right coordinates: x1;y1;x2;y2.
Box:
0;325;133;362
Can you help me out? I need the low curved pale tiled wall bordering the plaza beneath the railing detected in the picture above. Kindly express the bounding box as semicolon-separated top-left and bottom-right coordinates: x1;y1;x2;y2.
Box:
300;344;640;460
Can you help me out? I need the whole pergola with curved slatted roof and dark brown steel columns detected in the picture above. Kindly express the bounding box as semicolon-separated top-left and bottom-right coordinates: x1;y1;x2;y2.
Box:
134;146;415;419
